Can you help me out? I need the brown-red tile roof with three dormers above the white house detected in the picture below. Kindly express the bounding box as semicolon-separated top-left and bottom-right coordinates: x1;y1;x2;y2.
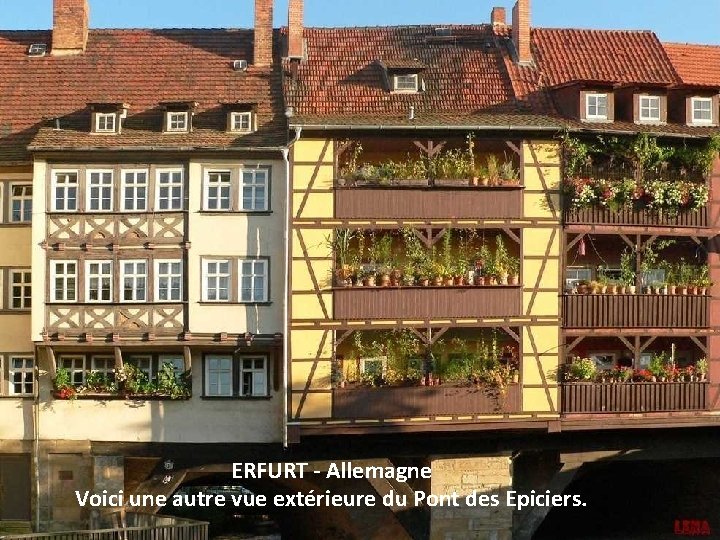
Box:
0;30;286;162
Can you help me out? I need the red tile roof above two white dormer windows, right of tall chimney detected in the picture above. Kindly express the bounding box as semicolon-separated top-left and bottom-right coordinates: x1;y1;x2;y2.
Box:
532;28;678;86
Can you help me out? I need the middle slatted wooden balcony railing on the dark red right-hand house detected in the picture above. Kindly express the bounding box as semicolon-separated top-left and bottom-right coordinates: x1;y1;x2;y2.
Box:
563;294;710;328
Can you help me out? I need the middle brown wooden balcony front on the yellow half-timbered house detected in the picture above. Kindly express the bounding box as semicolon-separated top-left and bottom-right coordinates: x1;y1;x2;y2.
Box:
334;286;522;320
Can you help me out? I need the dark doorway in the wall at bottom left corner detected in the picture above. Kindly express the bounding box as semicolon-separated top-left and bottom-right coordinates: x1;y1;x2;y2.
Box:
0;454;30;521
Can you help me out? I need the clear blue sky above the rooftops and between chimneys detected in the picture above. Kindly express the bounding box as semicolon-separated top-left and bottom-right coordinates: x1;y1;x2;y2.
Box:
0;0;720;44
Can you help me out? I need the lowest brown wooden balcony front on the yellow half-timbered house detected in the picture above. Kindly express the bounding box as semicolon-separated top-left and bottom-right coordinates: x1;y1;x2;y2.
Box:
332;384;521;419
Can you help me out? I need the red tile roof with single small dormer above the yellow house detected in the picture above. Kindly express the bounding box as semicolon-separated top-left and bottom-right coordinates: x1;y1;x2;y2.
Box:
285;25;549;124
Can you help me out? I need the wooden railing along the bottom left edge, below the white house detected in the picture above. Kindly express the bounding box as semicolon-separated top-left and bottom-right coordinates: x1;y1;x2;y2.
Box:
0;516;208;540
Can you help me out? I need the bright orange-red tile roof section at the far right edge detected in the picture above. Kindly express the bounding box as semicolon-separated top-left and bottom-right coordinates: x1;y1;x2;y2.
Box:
663;43;720;87
